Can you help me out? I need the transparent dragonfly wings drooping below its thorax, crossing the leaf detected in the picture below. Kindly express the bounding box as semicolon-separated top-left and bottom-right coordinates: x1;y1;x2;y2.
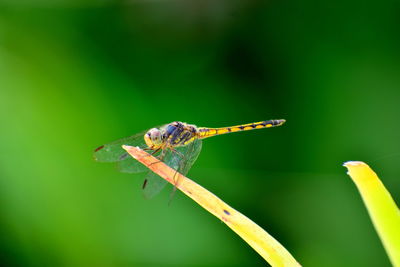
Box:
143;139;202;198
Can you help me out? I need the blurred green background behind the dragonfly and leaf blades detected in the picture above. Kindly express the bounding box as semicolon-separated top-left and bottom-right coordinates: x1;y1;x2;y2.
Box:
0;0;400;266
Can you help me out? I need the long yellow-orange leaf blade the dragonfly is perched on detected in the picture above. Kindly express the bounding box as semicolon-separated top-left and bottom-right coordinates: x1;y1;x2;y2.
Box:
122;146;300;266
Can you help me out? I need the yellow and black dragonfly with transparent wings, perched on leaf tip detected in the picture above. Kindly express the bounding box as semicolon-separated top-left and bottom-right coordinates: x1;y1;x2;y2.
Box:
94;119;286;198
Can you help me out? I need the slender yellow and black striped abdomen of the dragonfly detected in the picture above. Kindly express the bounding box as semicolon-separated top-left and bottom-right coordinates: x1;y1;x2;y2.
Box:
197;120;285;139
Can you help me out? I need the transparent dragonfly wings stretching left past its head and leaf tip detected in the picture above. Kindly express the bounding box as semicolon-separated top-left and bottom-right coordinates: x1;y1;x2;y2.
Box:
93;131;147;173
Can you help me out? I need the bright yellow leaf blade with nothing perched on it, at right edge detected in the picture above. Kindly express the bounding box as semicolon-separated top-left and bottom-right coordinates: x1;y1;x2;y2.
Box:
344;161;400;266
